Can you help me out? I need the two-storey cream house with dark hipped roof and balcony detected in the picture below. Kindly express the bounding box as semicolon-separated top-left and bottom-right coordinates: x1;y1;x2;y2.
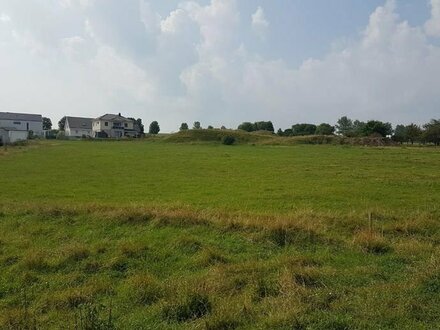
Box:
92;114;137;138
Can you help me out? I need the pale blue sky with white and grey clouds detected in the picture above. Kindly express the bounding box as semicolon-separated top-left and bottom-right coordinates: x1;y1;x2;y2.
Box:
0;0;440;131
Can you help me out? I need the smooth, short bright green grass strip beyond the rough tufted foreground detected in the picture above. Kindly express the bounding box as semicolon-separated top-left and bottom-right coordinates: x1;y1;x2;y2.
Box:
0;142;440;214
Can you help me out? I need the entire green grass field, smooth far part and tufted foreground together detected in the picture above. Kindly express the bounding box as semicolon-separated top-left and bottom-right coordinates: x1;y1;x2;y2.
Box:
0;140;440;329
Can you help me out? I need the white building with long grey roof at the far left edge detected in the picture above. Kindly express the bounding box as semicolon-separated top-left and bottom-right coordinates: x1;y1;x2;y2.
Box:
0;112;44;143
